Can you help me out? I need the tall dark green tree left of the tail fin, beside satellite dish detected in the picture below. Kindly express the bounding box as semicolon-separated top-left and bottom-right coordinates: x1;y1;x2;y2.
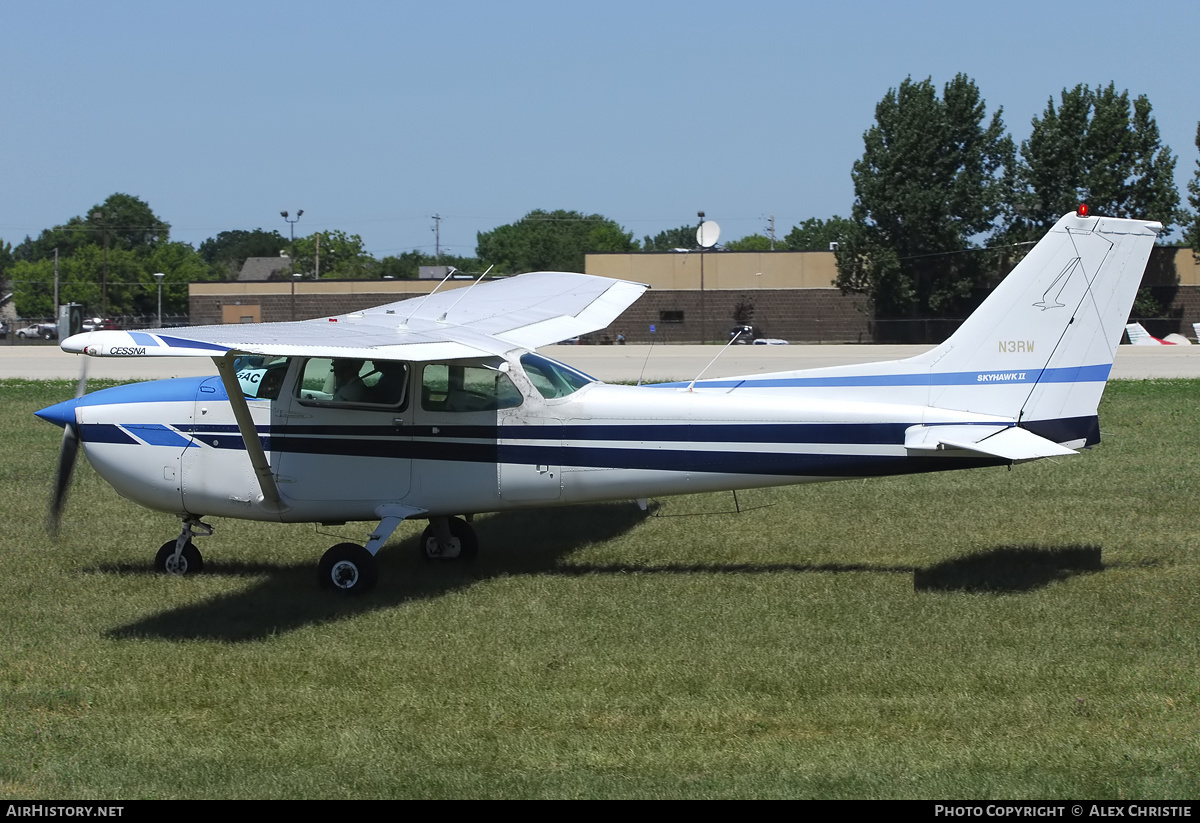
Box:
838;74;1014;318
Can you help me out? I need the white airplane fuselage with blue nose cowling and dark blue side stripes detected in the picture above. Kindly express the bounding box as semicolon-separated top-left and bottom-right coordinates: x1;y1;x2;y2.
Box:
68;356;1013;522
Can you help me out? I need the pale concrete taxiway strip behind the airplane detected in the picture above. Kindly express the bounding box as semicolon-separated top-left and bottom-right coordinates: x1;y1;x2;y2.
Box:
0;342;1200;383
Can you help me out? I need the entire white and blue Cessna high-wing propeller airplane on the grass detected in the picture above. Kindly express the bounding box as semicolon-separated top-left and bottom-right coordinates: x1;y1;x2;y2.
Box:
37;209;1160;594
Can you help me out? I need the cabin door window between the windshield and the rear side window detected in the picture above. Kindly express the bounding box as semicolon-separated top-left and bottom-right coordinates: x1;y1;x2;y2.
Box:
296;358;408;409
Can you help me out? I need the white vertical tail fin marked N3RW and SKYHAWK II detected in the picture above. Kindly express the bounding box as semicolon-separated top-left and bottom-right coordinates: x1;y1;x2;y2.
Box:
912;214;1162;443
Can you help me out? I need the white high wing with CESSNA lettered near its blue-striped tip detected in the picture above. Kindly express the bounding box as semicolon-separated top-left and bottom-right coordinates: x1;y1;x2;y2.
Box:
61;271;649;361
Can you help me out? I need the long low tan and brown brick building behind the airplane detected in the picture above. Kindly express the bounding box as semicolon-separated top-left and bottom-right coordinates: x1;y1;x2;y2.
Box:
190;247;1200;343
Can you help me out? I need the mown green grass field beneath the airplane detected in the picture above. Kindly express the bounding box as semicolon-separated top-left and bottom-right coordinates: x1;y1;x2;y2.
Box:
0;380;1200;800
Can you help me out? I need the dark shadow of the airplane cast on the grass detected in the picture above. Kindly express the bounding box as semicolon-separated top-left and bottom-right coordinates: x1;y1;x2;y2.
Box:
100;504;1103;643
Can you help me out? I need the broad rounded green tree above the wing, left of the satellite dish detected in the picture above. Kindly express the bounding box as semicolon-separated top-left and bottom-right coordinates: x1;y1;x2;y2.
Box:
475;209;637;274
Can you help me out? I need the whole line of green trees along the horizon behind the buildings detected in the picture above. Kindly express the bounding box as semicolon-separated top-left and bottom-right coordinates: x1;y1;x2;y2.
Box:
0;74;1200;318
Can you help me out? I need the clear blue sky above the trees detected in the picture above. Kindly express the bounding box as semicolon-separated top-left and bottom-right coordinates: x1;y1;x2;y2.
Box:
0;0;1200;257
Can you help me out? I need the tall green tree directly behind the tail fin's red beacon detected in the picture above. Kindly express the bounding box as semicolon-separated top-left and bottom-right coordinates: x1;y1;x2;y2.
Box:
1008;83;1181;240
